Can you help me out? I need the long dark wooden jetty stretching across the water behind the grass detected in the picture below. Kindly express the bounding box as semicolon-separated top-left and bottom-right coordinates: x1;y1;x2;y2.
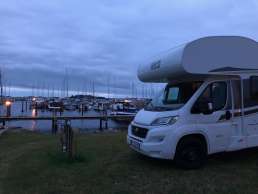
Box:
0;115;134;132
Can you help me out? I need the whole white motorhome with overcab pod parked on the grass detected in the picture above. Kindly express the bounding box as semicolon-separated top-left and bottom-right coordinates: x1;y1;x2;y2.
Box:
127;36;258;168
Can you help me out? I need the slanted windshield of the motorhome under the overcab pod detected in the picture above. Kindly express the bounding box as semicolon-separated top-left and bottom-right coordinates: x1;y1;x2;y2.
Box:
145;81;203;111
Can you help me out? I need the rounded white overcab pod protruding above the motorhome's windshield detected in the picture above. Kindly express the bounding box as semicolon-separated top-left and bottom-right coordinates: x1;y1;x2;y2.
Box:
138;36;258;82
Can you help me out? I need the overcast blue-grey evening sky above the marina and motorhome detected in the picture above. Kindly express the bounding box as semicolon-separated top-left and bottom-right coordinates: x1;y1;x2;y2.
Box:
0;0;258;97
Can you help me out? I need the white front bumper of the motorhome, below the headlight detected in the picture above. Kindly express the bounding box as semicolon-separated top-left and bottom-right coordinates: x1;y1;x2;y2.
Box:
127;125;174;159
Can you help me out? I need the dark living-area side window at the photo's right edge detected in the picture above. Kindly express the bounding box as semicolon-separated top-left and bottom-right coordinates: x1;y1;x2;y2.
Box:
244;76;258;108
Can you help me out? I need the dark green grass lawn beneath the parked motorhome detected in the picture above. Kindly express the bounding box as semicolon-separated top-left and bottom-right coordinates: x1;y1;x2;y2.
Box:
0;132;258;194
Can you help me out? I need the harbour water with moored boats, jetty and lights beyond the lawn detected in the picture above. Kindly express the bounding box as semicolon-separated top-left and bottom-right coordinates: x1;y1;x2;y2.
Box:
0;95;145;133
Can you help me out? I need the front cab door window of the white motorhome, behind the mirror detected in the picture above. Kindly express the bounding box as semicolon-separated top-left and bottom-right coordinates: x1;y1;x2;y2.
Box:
192;82;228;114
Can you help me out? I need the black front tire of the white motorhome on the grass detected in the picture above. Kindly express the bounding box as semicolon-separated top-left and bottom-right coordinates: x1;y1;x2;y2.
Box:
174;137;207;169
